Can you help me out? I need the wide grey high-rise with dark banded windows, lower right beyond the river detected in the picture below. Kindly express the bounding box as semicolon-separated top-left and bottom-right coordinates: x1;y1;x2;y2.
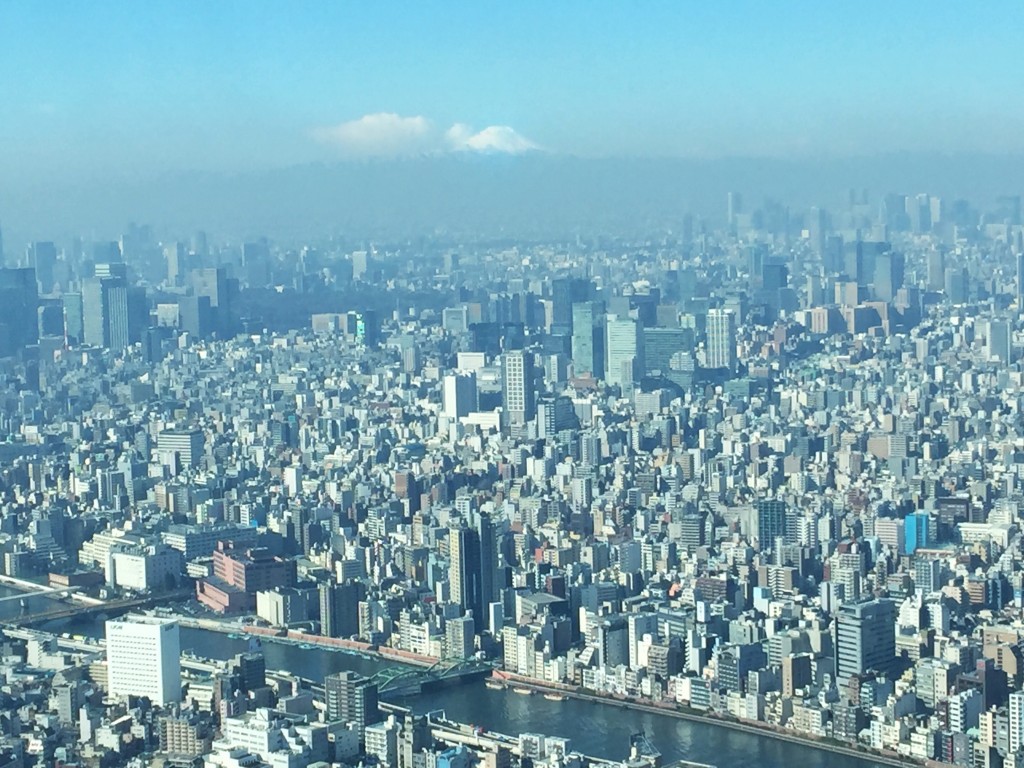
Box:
835;599;896;681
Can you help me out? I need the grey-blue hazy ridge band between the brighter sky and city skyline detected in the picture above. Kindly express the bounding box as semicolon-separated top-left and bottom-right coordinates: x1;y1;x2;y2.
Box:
0;152;1024;243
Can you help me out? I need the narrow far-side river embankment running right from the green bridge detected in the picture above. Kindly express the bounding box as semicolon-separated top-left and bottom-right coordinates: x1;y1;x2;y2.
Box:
493;672;917;768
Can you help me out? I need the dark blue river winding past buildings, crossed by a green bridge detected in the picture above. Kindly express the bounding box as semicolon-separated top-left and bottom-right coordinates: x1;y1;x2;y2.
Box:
18;601;879;768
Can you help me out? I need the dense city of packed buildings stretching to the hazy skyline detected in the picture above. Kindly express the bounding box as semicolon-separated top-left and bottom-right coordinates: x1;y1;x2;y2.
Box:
0;190;1024;768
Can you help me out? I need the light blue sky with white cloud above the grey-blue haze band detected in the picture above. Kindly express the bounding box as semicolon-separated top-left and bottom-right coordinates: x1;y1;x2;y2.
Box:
0;0;1024;179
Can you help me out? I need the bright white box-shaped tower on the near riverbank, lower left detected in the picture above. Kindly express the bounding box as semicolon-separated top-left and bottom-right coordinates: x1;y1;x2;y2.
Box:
106;615;181;705
